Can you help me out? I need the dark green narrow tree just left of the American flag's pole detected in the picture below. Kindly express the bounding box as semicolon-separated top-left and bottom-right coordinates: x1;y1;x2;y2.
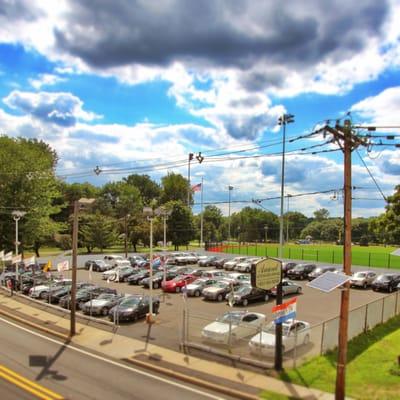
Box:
166;201;195;250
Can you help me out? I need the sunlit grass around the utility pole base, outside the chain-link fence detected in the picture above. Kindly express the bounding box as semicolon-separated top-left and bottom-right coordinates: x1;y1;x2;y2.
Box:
281;316;400;400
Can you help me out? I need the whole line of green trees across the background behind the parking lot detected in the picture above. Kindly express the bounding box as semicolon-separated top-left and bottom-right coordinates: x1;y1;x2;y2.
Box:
0;136;400;256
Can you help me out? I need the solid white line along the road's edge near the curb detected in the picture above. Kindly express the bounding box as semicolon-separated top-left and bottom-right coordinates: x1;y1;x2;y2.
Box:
0;317;224;400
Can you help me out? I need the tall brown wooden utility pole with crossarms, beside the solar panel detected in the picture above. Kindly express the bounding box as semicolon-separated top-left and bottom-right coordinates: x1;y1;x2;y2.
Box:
325;120;367;400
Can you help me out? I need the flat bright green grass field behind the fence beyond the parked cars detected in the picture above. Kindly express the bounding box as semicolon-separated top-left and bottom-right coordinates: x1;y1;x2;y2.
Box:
209;243;400;269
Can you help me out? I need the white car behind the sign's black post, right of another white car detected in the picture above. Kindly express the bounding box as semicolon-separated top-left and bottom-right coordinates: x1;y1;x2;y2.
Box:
249;320;311;356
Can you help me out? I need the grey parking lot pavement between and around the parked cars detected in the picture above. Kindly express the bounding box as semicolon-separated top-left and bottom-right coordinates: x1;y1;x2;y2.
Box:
67;268;387;350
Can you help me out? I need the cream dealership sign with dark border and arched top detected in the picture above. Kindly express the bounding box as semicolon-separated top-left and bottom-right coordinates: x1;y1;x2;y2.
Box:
251;258;282;290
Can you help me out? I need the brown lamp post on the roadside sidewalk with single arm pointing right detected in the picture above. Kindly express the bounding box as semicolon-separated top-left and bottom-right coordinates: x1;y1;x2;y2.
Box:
69;198;95;336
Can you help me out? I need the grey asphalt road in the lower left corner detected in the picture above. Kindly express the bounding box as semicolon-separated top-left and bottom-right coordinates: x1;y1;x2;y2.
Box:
0;318;231;400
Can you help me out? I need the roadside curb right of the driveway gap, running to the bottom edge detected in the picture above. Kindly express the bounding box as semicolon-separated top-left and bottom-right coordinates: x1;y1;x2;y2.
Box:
122;358;262;400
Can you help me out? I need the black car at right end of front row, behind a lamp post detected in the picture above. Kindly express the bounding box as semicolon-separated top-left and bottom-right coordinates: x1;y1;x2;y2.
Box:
108;296;160;321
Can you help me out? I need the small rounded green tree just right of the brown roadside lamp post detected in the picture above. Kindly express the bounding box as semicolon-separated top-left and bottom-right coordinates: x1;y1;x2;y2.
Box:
80;212;118;253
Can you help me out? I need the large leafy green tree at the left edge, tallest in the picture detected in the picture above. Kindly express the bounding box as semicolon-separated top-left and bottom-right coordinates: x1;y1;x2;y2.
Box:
0;136;62;256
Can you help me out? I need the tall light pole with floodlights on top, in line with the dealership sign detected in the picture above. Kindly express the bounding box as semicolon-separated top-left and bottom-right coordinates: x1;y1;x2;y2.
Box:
275;114;294;371
